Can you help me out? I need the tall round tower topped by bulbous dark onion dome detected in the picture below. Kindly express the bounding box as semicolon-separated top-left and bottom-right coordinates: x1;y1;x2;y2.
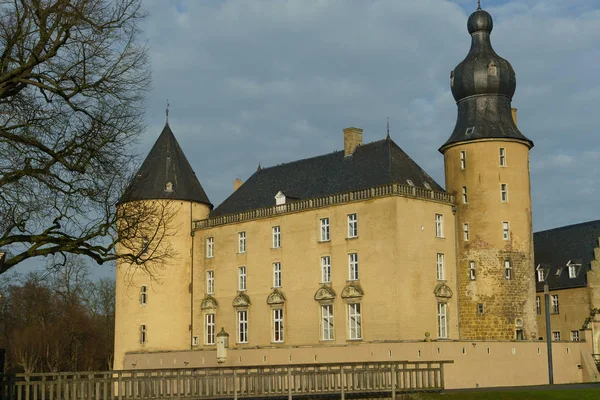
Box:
440;3;537;340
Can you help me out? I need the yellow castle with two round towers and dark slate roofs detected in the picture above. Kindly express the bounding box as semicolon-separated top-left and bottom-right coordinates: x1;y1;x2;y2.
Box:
115;8;600;388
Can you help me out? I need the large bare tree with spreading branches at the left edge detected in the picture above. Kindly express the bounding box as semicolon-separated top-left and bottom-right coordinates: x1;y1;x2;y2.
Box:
0;0;176;273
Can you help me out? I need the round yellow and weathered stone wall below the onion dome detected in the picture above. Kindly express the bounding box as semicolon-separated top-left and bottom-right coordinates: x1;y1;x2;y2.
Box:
444;140;537;340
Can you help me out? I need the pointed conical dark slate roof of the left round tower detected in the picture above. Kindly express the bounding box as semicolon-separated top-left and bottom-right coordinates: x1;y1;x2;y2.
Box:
119;123;213;209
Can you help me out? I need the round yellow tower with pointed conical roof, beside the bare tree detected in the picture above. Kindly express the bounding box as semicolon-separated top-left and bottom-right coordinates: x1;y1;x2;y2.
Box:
114;123;213;369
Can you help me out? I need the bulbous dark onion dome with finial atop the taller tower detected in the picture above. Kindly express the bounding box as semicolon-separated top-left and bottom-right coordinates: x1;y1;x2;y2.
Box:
440;7;533;152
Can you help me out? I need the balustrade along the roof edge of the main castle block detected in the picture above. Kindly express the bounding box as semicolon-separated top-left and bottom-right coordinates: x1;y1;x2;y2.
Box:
194;183;454;230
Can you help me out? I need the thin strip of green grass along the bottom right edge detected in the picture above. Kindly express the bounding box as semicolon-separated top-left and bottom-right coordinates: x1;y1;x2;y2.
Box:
401;387;600;400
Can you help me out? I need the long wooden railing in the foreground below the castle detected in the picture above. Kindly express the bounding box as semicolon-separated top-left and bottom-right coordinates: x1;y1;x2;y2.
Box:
0;361;452;400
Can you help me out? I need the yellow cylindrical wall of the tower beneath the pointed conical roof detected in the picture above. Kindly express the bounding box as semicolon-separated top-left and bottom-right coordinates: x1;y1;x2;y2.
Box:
114;200;208;369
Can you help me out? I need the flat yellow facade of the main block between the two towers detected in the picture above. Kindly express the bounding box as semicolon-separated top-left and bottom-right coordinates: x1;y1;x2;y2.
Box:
193;196;458;348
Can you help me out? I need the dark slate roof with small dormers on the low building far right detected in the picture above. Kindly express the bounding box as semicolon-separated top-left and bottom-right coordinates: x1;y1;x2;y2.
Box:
533;220;600;292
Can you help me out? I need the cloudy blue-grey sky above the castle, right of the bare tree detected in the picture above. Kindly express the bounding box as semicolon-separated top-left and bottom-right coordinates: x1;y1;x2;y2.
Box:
136;0;600;231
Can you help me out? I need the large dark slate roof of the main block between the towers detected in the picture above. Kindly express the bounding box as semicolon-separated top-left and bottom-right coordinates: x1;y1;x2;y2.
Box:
211;139;444;217
